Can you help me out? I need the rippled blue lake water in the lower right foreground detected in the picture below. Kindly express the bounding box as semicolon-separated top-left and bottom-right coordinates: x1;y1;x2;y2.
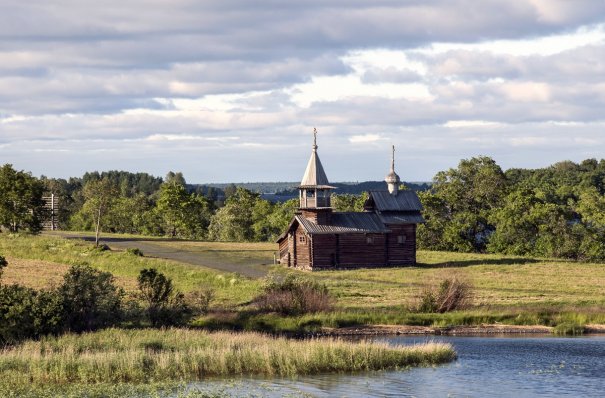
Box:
191;336;605;398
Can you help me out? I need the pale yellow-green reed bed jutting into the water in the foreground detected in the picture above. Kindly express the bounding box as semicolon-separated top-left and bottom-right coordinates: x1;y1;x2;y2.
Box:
0;329;456;386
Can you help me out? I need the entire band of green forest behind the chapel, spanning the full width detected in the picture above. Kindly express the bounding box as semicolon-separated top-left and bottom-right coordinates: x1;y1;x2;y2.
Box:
0;157;605;260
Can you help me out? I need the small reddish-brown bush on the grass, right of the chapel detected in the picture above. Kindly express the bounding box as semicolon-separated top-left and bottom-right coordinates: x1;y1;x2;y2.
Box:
417;278;472;313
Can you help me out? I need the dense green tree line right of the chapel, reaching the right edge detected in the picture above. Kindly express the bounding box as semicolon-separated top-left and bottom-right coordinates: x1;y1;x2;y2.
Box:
418;157;605;260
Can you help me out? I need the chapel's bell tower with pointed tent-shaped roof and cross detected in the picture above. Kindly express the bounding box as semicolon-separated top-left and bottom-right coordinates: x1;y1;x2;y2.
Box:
298;128;334;224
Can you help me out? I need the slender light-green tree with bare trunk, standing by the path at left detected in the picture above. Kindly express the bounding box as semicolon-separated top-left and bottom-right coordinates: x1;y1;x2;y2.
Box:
82;179;118;247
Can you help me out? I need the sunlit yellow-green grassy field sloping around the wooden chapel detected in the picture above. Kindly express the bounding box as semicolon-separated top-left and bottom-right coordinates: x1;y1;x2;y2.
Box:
0;235;605;331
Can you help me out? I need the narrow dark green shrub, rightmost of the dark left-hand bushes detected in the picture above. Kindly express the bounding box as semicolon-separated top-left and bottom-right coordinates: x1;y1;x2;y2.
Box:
137;268;192;327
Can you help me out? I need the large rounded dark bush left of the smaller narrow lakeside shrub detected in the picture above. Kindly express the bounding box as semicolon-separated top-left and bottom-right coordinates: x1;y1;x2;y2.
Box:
59;265;124;332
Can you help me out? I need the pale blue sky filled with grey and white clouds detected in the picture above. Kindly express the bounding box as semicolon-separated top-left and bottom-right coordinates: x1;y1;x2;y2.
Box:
0;0;605;183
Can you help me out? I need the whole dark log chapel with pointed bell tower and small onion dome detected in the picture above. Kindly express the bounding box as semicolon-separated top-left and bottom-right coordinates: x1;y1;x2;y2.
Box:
277;131;424;270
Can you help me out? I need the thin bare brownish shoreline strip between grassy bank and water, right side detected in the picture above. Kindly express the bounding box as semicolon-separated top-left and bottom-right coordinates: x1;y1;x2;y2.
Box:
319;324;605;336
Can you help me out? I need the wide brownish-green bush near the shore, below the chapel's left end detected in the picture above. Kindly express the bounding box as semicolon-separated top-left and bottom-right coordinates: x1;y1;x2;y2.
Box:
254;274;333;315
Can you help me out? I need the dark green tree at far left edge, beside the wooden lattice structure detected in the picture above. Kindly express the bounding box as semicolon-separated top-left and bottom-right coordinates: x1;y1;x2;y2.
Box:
0;164;47;233
